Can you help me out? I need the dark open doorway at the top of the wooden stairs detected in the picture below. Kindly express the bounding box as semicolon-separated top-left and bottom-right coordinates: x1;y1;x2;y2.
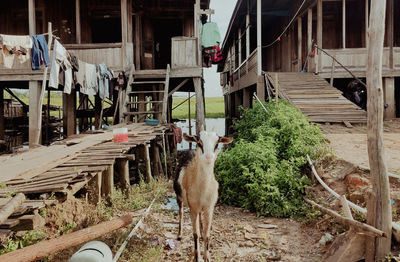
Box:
153;19;183;69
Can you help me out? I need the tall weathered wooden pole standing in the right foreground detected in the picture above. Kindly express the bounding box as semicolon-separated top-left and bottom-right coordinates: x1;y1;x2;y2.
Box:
366;0;392;261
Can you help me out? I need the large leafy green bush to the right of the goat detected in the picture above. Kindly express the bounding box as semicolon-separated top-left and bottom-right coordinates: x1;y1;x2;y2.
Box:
215;101;325;217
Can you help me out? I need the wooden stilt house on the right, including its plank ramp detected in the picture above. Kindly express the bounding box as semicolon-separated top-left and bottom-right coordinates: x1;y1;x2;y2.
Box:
218;0;400;135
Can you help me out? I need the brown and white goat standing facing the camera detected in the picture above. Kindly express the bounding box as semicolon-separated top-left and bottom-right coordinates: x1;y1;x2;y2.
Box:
174;129;232;262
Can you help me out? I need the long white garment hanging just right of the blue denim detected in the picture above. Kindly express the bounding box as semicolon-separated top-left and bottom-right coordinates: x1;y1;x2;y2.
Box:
49;39;72;94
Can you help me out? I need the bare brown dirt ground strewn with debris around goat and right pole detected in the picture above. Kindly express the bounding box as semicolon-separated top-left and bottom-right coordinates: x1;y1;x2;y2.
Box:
3;121;400;262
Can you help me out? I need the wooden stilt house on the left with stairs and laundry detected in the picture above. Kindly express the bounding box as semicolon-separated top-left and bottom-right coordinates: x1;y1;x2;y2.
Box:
0;0;209;148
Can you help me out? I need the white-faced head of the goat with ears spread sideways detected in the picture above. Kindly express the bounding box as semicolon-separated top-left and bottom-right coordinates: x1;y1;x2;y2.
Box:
183;127;233;164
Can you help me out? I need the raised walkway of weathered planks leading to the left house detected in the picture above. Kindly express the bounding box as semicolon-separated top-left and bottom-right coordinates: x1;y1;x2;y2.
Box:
0;123;169;197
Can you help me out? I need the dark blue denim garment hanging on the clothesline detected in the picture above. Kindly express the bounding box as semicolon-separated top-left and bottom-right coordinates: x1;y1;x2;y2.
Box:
31;35;50;70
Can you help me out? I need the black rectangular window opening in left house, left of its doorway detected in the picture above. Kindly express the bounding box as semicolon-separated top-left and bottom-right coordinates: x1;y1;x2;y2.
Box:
91;18;122;43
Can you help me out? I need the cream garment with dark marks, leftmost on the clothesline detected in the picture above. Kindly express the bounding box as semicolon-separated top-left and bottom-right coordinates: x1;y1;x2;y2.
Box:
0;34;32;68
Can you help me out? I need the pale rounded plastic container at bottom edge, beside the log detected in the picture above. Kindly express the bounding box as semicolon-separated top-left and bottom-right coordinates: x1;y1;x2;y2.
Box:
68;241;112;262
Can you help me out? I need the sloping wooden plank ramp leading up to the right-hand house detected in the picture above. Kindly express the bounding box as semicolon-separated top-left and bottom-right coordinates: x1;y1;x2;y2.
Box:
267;72;367;123
